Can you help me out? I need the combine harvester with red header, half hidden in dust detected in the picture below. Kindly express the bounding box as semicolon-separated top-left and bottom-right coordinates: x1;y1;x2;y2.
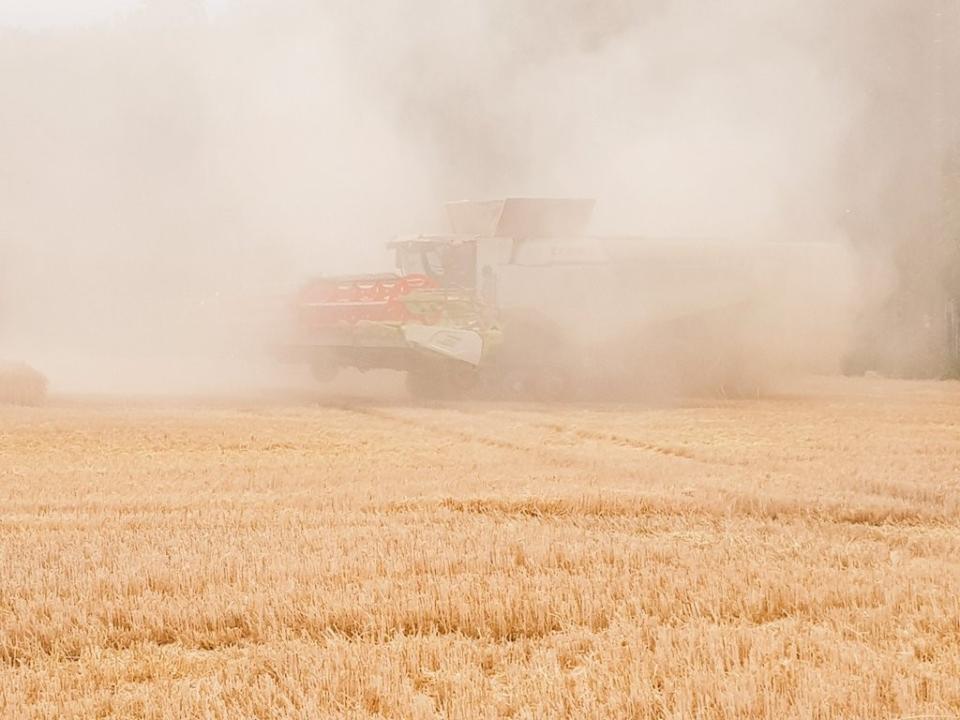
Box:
284;199;852;400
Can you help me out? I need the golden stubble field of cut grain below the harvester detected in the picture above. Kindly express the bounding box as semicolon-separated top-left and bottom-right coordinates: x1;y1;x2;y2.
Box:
0;380;960;719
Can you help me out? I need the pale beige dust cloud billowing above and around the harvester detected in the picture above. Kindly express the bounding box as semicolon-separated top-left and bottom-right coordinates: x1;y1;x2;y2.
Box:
0;0;956;392
